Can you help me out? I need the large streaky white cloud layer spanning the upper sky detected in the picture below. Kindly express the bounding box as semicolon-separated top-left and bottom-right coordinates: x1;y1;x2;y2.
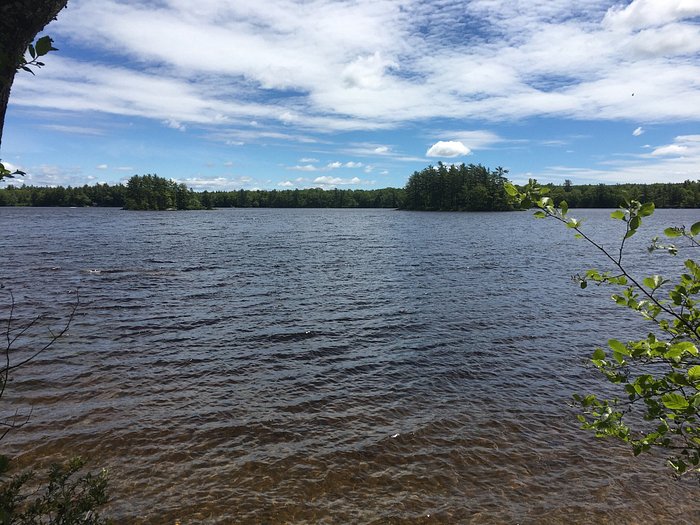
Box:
5;0;700;143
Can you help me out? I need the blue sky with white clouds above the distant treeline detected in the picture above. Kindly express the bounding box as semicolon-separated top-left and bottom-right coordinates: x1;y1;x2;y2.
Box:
0;0;700;191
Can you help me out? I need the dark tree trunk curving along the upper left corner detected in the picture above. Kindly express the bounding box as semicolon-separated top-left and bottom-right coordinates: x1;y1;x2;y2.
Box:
0;0;68;150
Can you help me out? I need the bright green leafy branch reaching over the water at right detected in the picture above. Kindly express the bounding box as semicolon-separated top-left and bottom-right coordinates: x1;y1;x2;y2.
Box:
506;180;700;475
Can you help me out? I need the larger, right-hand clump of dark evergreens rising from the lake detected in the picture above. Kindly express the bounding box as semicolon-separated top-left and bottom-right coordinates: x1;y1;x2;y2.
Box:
403;162;512;211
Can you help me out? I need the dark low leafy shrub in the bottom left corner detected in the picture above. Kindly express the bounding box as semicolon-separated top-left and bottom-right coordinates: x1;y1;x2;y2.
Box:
0;457;109;525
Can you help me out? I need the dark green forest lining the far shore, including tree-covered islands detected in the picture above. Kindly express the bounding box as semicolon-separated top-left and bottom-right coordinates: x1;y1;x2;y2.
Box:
0;169;700;211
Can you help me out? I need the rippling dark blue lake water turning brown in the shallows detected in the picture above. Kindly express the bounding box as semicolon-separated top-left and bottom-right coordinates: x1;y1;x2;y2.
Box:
0;208;700;525
